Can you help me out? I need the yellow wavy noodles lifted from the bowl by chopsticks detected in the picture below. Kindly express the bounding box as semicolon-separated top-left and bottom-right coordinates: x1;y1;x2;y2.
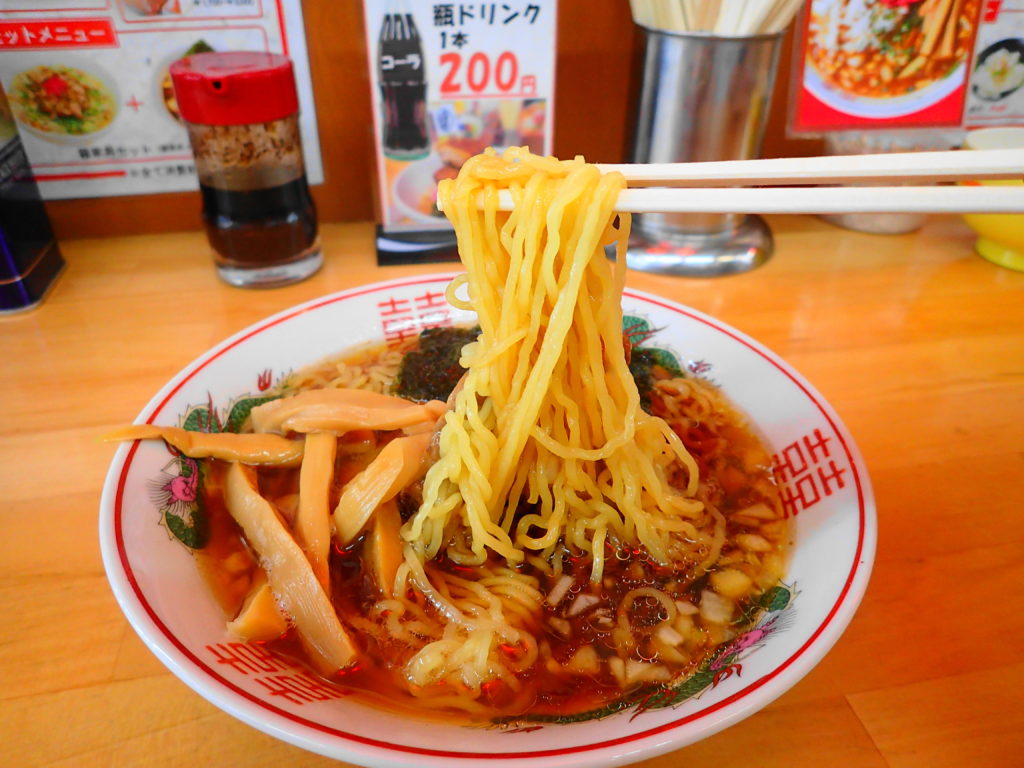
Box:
402;148;708;582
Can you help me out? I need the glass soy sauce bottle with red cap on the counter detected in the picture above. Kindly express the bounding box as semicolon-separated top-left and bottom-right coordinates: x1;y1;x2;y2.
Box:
170;51;324;288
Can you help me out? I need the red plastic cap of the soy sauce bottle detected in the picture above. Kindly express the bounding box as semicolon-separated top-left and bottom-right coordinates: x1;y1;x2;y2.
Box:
170;51;299;125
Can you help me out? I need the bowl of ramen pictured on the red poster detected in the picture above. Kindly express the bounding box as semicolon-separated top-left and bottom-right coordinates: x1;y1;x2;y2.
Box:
804;0;980;118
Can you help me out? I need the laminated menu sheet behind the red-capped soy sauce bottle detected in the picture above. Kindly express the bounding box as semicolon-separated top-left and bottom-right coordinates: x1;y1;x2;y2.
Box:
0;0;324;200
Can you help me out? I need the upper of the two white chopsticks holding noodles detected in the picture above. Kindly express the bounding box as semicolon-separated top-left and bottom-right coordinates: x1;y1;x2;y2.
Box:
598;150;1024;187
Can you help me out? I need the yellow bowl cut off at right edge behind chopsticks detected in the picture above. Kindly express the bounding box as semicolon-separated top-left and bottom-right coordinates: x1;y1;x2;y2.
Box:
964;128;1024;271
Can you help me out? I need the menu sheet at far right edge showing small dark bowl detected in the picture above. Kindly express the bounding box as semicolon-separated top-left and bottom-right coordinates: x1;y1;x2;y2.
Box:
965;0;1024;128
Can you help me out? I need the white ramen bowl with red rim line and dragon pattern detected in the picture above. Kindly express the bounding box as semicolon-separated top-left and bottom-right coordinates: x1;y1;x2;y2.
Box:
99;274;876;768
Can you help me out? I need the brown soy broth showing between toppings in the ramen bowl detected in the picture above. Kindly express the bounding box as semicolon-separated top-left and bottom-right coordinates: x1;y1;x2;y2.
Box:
186;339;790;722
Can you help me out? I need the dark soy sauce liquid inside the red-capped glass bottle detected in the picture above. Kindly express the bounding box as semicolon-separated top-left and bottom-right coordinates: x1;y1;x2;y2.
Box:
200;176;317;266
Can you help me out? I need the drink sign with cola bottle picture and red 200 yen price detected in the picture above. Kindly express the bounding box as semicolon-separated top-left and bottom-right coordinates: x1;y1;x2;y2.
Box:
365;0;556;260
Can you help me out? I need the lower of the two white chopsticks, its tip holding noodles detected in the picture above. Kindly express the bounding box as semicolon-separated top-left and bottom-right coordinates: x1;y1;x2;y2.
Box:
437;185;1024;213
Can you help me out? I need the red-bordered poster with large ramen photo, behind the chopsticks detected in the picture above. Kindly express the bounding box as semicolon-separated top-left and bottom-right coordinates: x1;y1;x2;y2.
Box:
790;0;991;133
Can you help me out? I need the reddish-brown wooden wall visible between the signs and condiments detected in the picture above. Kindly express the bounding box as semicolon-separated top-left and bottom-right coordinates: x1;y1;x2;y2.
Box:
46;0;823;240
